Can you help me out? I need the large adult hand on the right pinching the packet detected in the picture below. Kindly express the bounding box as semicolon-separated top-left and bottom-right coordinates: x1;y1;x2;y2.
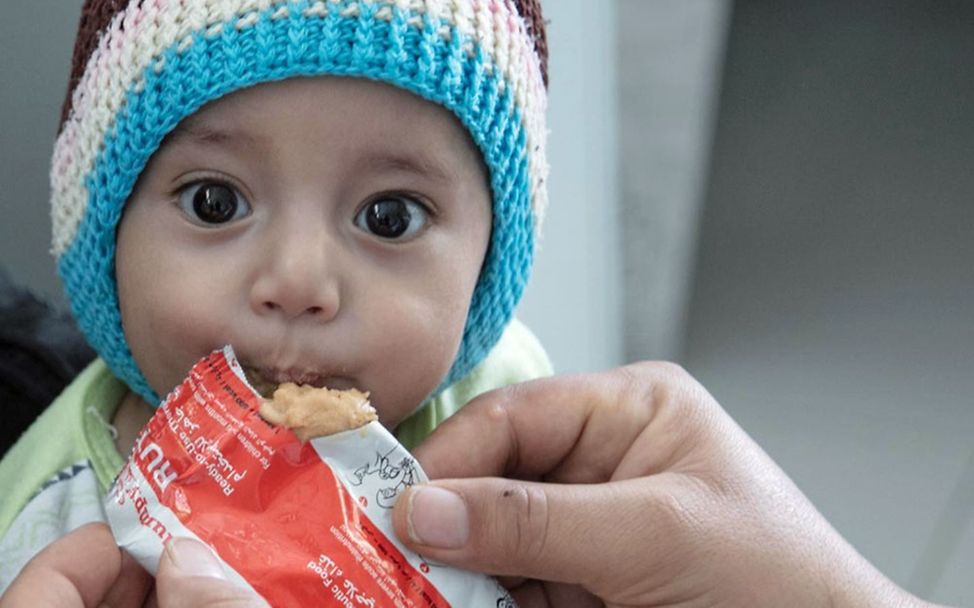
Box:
394;363;936;608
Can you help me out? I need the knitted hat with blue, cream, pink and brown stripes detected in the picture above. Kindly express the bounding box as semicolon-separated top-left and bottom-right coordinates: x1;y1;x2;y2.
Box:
51;0;548;403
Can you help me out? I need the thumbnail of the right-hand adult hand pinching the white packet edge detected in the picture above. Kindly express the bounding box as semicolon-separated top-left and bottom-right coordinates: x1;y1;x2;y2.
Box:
408;486;470;549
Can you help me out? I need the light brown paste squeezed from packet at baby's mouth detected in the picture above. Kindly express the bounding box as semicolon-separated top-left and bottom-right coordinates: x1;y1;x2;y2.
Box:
259;382;378;442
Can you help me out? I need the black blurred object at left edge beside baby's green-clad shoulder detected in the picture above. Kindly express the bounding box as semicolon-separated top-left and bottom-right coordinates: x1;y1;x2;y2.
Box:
0;268;95;456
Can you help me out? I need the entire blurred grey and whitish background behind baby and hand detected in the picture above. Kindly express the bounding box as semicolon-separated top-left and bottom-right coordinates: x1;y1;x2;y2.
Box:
0;0;974;605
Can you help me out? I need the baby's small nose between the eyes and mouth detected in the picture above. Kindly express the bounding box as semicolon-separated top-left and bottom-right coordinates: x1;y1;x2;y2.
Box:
251;228;341;321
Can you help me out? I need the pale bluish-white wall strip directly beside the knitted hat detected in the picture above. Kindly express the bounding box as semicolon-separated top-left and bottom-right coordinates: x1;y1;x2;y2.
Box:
518;0;622;372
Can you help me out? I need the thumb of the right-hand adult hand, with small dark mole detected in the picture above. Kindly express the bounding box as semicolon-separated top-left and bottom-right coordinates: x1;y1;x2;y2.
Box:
393;478;665;593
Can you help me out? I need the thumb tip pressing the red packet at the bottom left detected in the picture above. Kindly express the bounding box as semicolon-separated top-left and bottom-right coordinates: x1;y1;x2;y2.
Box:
156;538;268;608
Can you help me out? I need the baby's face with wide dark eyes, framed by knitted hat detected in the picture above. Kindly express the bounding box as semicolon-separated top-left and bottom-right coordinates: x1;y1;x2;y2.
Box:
116;78;491;428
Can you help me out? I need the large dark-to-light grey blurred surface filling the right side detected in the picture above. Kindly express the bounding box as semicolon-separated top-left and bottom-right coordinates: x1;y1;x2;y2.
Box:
684;0;974;605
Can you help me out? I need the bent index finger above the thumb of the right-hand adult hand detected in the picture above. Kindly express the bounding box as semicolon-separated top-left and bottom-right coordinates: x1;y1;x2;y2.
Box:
414;368;654;483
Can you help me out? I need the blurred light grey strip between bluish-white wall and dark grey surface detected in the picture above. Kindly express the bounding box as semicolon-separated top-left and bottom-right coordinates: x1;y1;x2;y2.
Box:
618;0;731;360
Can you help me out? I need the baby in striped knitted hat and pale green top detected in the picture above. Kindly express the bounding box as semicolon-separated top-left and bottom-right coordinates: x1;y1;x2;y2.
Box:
0;0;550;591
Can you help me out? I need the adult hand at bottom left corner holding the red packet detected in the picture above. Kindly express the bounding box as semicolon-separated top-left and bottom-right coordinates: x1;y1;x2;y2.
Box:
0;523;267;608
